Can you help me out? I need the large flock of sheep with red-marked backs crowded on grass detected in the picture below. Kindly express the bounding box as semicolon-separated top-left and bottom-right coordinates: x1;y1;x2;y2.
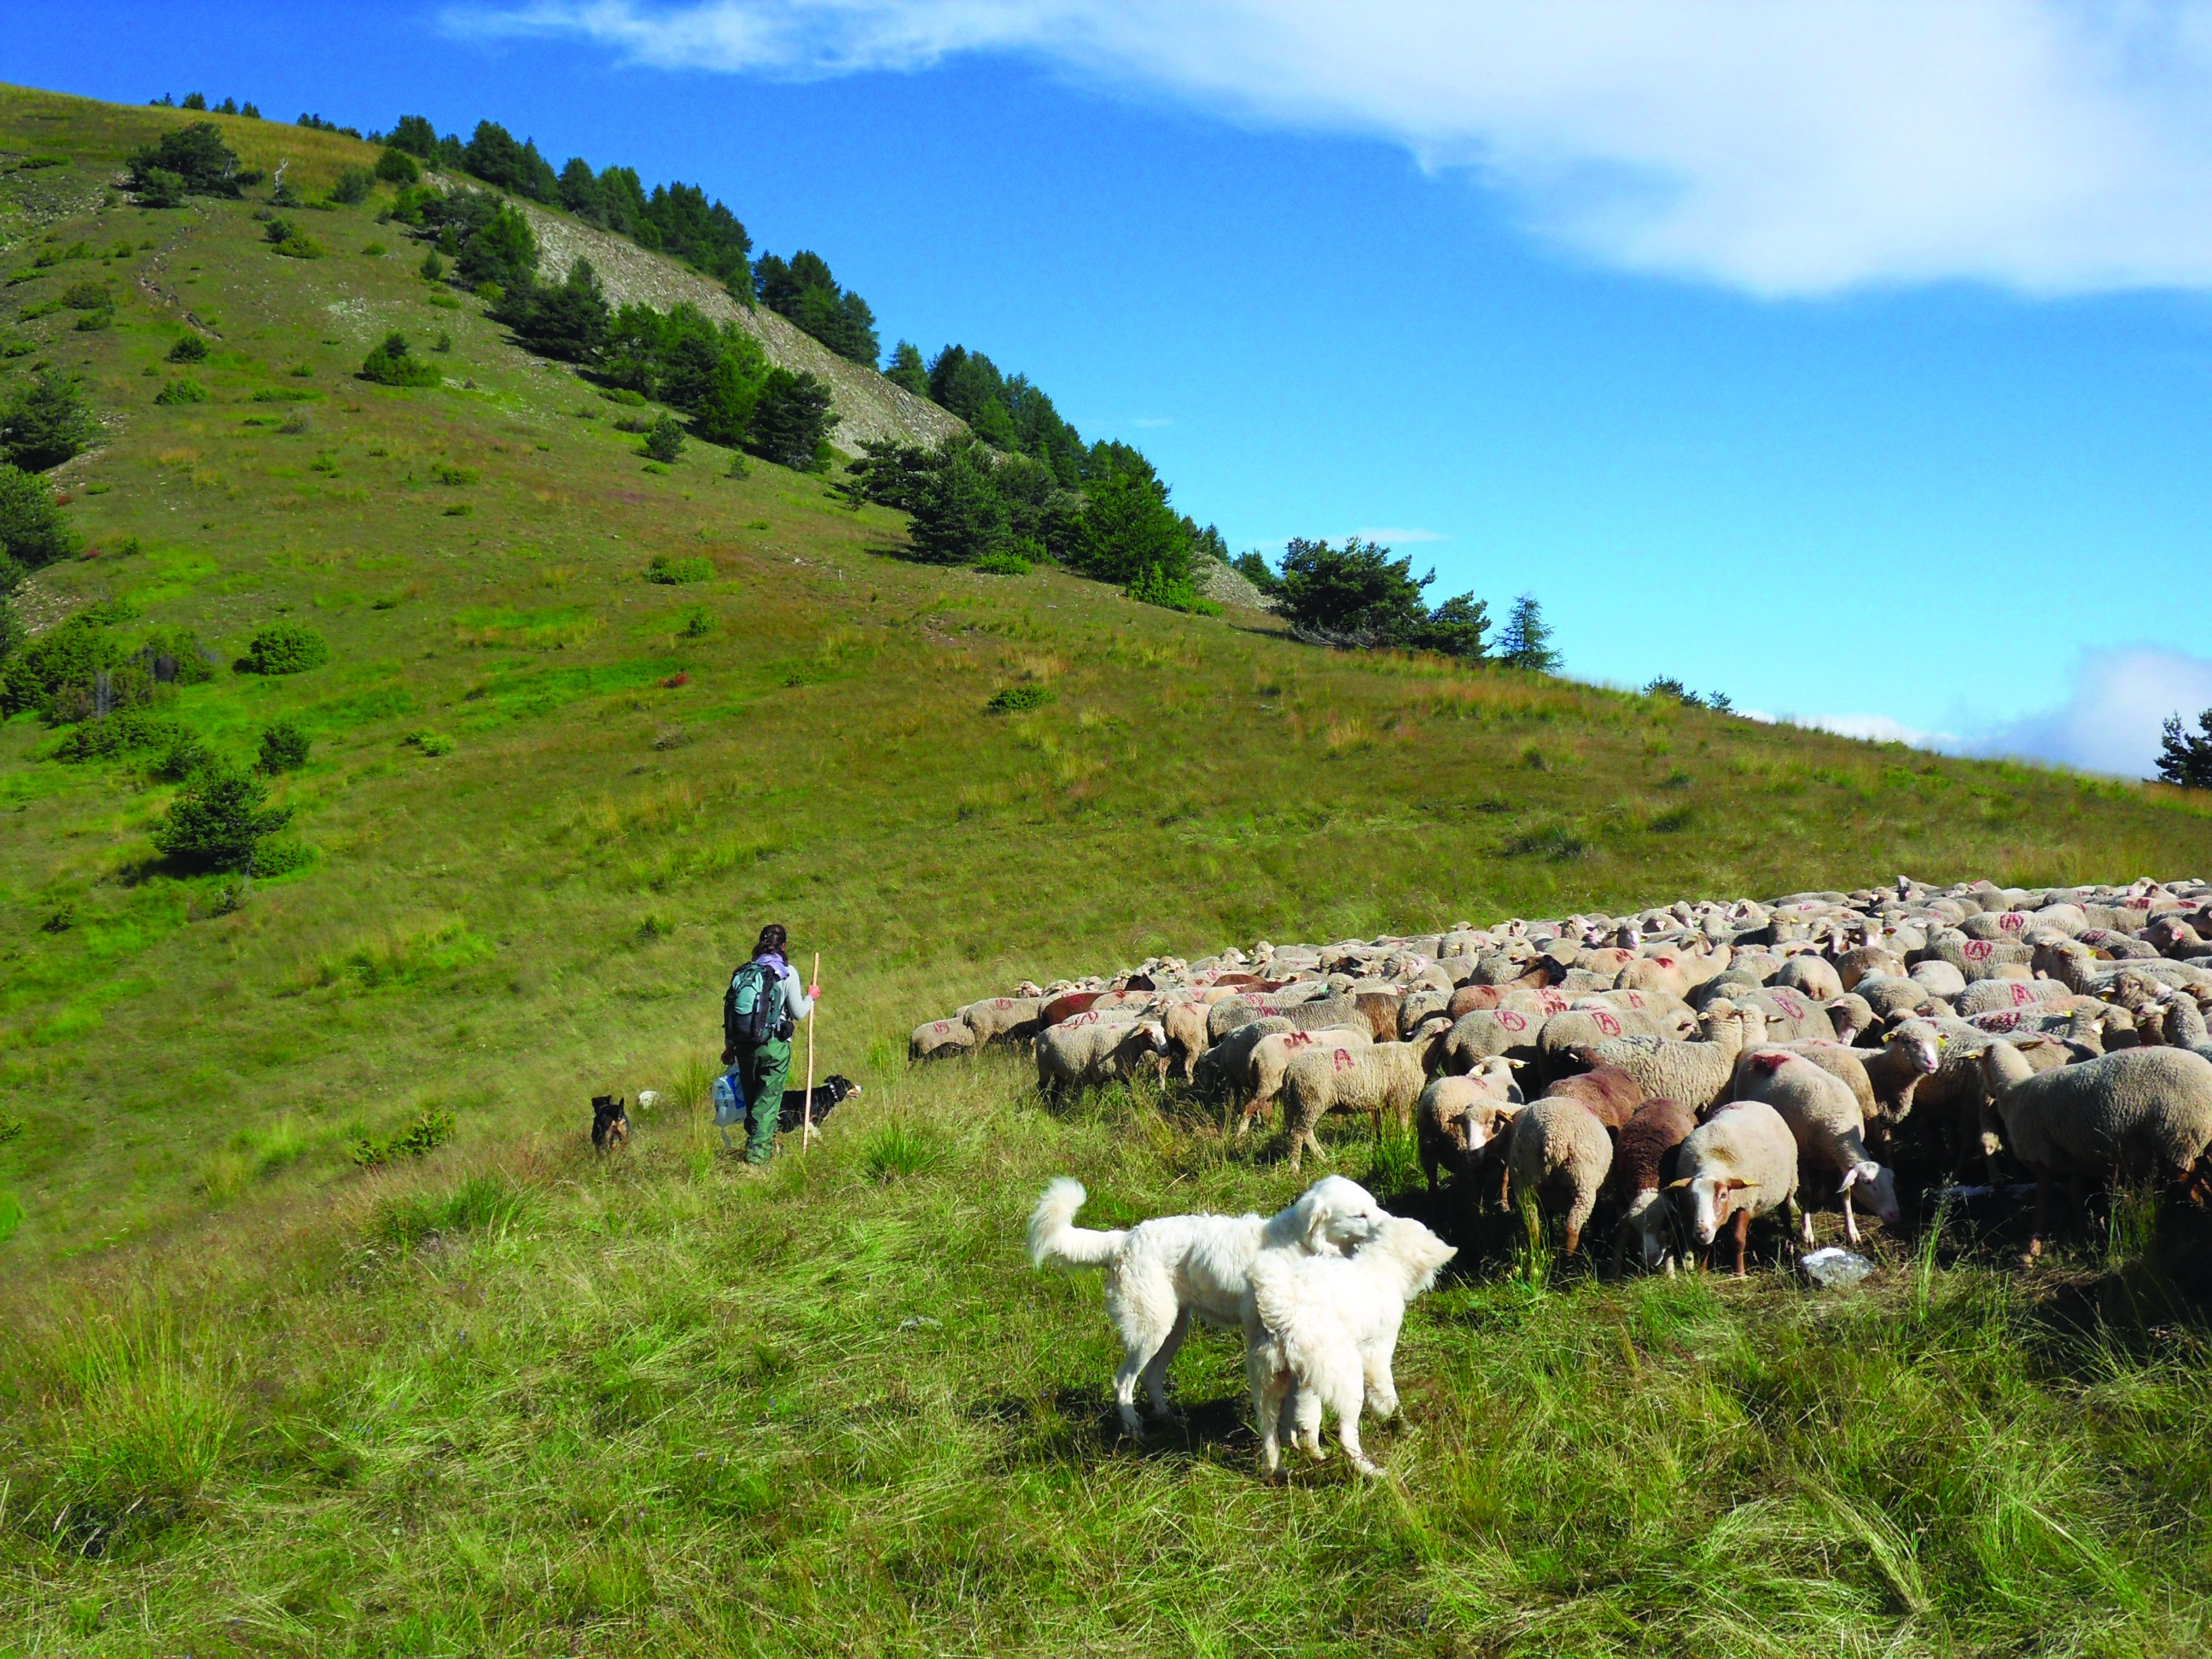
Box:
909;876;2212;1274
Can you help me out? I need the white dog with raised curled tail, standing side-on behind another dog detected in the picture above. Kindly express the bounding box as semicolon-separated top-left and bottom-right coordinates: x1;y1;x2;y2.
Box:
1028;1174;1389;1435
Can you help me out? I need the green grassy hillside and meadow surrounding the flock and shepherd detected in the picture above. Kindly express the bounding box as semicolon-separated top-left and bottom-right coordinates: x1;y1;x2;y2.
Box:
13;90;2212;1652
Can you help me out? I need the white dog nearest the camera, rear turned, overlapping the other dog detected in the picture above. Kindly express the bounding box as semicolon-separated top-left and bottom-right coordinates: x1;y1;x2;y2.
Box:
1245;1217;1460;1476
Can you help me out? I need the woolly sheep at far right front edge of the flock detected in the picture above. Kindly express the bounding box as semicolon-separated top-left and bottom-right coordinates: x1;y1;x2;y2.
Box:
1982;1042;2212;1259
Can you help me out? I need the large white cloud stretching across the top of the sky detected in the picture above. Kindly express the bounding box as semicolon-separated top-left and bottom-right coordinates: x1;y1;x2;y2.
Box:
471;0;2212;294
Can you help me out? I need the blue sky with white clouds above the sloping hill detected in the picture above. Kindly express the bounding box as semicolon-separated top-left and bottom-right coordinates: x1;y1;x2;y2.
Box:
17;0;2212;770
